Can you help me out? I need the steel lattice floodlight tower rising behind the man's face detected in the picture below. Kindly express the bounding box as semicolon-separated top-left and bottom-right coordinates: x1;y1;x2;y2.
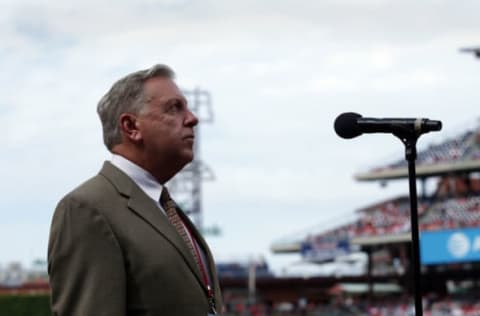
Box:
168;88;214;232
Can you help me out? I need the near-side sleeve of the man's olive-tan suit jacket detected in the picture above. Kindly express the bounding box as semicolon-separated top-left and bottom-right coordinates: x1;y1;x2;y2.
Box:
48;197;127;316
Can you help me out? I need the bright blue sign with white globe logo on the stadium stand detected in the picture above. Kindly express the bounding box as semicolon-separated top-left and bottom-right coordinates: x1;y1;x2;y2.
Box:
420;228;480;265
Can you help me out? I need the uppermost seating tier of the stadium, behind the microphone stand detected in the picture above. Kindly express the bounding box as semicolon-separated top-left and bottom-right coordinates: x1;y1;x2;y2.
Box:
355;127;480;181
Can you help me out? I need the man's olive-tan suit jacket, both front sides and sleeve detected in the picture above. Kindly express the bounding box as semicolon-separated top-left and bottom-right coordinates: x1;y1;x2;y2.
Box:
48;162;221;316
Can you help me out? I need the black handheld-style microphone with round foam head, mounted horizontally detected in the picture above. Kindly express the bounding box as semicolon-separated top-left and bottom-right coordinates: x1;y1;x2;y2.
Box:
334;112;442;139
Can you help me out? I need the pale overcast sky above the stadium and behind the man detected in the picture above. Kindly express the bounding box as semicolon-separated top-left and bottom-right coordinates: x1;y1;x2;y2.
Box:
0;0;480;268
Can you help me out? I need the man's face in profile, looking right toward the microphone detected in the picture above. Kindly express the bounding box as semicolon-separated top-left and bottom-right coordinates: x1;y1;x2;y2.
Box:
137;77;198;173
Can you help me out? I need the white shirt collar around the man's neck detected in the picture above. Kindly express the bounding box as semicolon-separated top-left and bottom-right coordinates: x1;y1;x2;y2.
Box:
111;154;163;203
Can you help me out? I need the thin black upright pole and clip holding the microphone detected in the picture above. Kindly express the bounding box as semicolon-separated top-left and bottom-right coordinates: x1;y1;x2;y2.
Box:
393;131;423;316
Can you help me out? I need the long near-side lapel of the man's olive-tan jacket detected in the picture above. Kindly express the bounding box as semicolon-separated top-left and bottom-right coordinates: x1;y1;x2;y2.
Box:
100;161;204;286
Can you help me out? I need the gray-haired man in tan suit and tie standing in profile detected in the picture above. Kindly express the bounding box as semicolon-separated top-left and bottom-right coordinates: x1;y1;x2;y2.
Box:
48;65;221;316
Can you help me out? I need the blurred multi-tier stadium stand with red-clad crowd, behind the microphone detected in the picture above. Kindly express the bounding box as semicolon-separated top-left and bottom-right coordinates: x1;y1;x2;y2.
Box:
264;122;480;316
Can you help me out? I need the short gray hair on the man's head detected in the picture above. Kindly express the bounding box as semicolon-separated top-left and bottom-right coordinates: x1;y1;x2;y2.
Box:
97;64;175;151
